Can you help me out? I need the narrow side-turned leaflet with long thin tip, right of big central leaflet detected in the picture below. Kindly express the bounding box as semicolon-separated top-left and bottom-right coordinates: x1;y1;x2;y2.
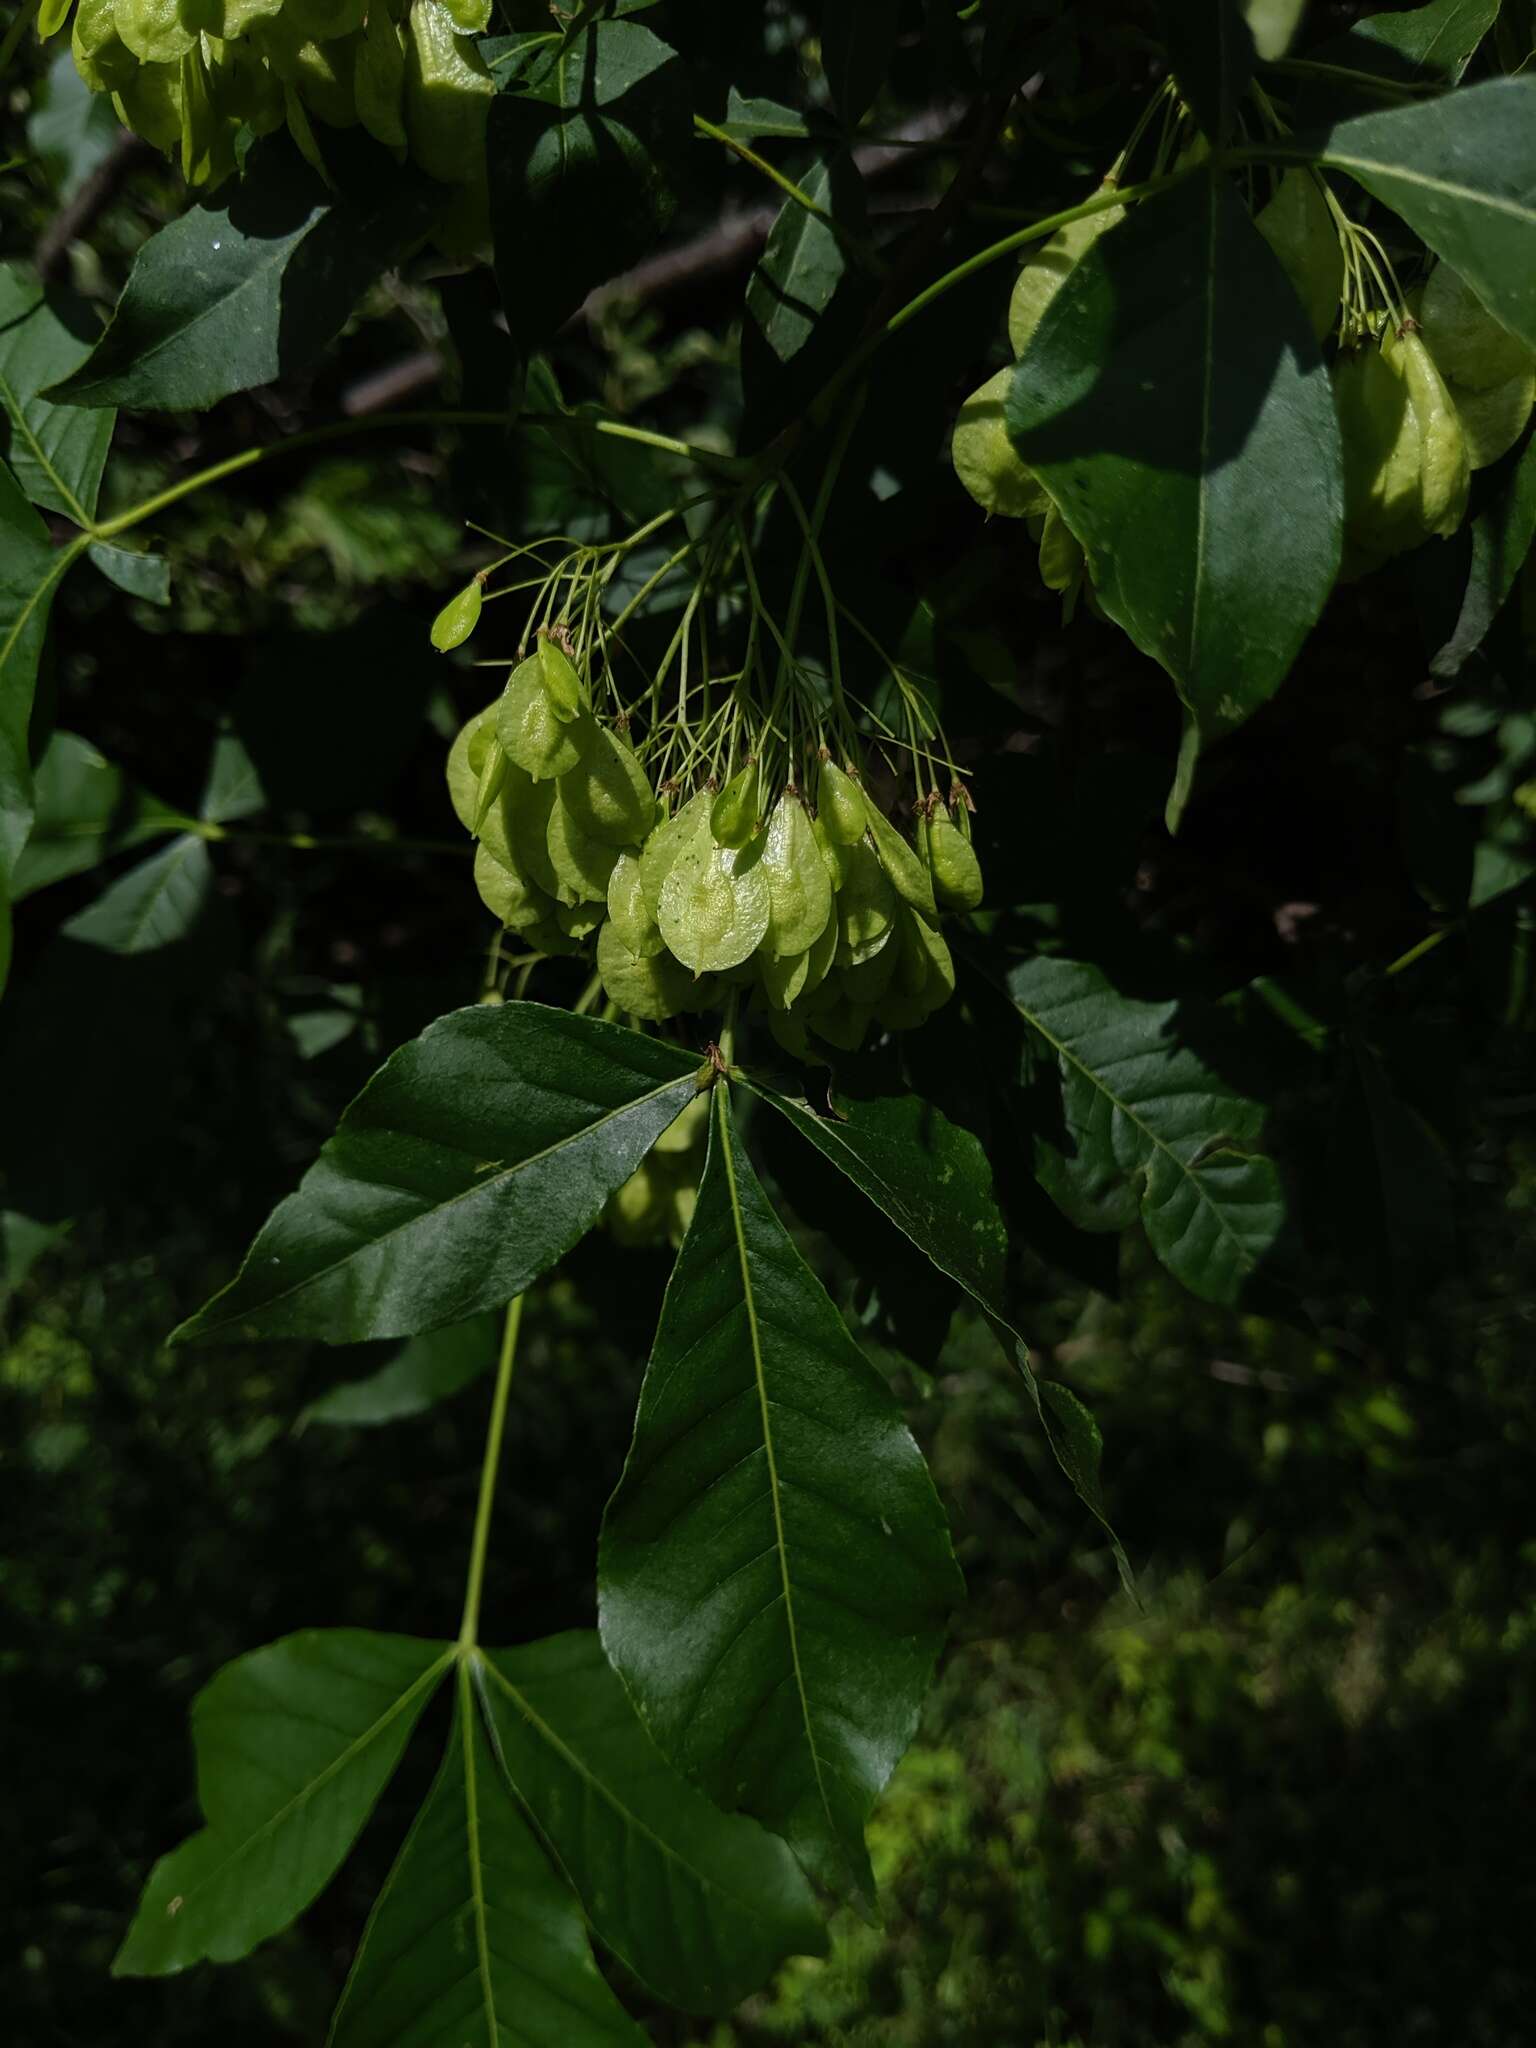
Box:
745;1081;1135;1597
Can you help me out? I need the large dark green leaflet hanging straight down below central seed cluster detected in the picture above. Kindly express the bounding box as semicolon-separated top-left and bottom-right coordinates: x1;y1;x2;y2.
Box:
598;1094;961;1898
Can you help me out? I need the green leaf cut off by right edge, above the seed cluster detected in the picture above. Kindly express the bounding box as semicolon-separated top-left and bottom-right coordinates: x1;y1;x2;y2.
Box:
1302;78;1536;348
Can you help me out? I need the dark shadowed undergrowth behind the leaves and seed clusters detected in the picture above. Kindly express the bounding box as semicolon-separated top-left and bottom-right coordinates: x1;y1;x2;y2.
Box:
0;0;1536;2048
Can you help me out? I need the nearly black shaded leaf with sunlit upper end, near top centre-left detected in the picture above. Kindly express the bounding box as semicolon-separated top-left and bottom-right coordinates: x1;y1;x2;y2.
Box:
485;20;692;354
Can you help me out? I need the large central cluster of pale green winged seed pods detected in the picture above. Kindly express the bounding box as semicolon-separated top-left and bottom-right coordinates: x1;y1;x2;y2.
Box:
450;626;981;1057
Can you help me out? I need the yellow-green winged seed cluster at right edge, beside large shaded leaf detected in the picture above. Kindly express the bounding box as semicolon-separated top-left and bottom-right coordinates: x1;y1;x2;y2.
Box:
1333;264;1536;575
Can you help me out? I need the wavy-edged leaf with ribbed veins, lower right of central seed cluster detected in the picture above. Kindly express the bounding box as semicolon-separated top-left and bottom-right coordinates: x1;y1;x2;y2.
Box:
1008;956;1286;1305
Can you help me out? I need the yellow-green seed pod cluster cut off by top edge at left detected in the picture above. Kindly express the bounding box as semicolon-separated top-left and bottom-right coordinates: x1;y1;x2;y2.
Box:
55;0;496;234
